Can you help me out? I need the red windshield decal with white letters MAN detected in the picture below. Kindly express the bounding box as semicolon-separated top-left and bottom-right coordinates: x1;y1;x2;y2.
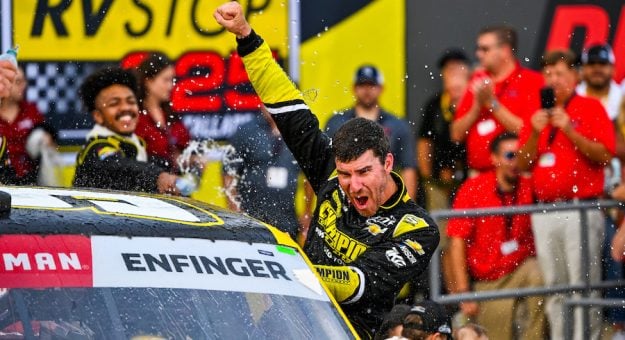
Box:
0;235;92;288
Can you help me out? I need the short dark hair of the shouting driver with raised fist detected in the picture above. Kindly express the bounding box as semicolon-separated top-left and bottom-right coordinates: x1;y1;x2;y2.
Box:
332;118;390;164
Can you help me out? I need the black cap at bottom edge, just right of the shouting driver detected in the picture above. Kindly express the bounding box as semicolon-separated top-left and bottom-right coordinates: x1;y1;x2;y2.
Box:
404;300;451;335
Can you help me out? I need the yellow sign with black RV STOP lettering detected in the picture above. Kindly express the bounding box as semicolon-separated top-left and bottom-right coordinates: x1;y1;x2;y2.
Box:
12;0;288;61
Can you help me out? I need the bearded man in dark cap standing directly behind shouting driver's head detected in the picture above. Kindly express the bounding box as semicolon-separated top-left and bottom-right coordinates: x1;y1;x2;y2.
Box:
326;65;417;198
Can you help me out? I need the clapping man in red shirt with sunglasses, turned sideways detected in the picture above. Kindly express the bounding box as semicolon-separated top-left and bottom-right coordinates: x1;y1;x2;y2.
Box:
450;26;543;171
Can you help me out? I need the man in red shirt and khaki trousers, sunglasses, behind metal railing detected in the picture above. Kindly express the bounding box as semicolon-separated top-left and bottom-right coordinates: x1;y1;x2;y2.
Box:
447;132;545;340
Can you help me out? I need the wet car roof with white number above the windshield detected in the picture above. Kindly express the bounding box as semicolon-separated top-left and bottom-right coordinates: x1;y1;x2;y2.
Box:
0;186;277;243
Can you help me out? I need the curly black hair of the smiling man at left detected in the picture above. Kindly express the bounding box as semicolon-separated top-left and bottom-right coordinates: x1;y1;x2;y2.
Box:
78;66;137;112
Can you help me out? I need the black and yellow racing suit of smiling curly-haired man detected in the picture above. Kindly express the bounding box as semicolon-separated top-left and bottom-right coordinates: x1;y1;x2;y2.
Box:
74;135;165;193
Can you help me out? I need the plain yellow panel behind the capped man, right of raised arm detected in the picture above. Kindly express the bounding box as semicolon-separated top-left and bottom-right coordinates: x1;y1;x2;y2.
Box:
300;0;406;122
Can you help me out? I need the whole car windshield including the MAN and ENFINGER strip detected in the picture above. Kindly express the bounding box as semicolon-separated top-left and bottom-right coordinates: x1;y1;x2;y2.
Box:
0;235;351;339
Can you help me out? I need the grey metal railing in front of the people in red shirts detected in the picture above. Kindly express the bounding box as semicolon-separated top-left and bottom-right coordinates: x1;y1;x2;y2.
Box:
429;200;625;339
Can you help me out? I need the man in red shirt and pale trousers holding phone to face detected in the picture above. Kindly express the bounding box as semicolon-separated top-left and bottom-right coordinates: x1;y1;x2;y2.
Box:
519;51;615;339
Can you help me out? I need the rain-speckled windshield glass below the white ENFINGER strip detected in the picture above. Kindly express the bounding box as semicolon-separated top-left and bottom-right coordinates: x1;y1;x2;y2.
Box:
0;288;352;339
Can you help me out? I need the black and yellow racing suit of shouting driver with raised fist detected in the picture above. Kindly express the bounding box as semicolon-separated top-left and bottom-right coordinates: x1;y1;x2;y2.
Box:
237;32;439;338
